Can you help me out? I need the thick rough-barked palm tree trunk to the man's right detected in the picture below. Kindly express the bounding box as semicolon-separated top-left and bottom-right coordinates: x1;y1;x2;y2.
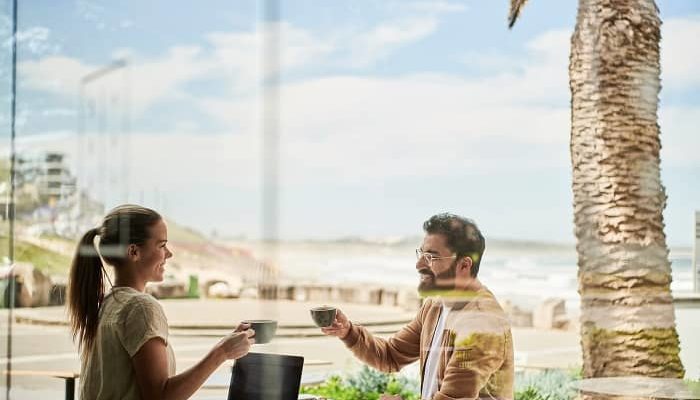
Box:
569;0;684;377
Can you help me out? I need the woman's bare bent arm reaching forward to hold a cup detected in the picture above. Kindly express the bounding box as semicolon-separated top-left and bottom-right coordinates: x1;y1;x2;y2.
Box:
132;326;255;400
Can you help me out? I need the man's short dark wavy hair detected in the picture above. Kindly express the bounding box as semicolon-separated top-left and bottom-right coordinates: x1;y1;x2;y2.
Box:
423;213;486;277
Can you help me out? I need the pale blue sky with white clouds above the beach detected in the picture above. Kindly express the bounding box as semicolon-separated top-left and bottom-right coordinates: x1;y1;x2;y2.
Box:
0;0;700;246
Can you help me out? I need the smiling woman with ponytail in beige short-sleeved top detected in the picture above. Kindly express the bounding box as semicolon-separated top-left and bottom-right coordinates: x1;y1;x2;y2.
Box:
68;205;255;400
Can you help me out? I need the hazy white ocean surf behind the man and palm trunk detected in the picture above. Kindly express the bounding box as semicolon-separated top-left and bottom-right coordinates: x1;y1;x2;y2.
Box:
256;242;693;314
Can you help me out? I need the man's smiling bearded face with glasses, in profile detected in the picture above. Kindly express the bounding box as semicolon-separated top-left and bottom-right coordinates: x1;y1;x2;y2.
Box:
416;233;457;292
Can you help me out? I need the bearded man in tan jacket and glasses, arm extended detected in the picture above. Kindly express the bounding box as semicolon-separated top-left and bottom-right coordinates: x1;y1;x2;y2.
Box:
322;214;513;400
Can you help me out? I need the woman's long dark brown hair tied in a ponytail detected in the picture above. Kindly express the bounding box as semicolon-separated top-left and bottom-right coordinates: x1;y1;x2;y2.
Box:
68;204;162;354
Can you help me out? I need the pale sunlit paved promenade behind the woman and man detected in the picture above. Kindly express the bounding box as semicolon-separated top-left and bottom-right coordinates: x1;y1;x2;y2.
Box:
0;299;580;399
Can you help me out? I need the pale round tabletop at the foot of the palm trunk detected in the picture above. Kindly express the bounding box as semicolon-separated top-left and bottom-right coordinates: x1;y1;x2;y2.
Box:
571;376;700;400
